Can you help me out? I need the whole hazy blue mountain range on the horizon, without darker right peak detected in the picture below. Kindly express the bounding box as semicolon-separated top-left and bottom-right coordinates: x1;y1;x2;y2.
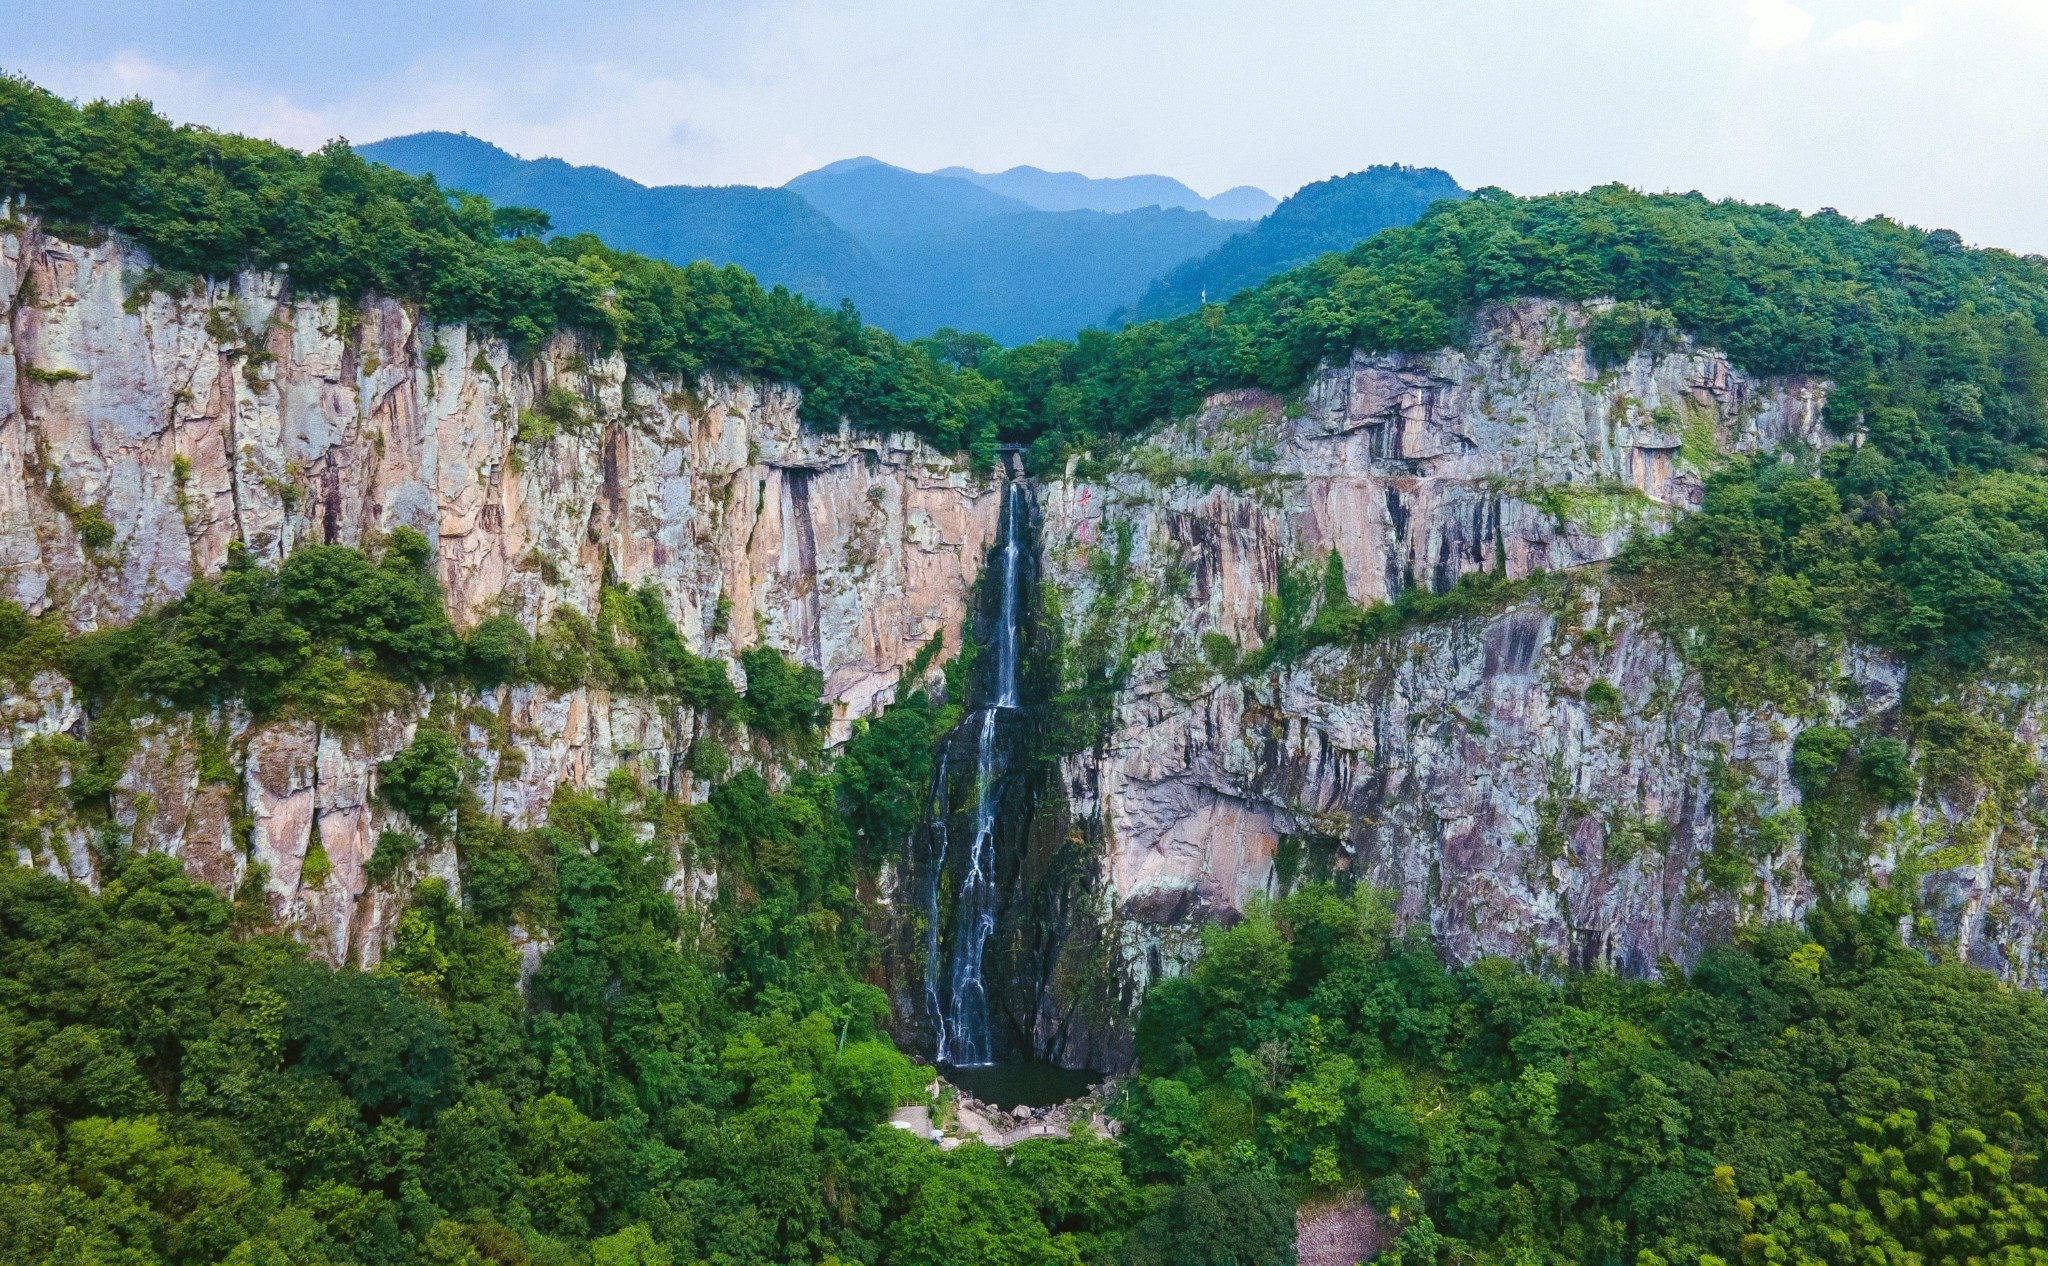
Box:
356;131;1335;342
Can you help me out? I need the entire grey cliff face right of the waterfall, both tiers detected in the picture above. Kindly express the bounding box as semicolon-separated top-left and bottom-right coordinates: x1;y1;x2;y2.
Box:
1044;301;2042;1059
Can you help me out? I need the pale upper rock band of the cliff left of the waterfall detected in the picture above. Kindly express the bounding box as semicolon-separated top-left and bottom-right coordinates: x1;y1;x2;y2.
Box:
0;225;997;725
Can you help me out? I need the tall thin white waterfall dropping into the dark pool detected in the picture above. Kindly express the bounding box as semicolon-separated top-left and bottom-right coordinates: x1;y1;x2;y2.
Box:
924;479;1024;1067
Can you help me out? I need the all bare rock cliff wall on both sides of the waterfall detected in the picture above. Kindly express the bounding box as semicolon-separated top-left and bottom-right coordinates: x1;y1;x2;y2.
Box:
0;221;2048;1071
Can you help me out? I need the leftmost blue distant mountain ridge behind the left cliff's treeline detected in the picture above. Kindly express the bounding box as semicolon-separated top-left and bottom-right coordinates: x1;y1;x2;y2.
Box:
356;131;888;318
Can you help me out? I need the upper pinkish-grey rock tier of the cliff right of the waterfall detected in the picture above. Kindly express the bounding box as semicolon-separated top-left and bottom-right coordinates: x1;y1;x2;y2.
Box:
1047;299;1831;630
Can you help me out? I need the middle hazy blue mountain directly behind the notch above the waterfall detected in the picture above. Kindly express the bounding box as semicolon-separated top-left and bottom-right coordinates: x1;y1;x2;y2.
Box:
868;207;1235;344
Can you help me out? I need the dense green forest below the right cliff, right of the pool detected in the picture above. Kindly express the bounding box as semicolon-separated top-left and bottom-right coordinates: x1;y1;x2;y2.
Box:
1124;887;2048;1266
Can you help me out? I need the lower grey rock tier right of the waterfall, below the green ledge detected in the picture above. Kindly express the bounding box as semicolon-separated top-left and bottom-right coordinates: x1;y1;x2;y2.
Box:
1069;586;2048;1011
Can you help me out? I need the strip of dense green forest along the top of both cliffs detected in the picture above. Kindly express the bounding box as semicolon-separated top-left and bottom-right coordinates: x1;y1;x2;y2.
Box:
0;80;2048;465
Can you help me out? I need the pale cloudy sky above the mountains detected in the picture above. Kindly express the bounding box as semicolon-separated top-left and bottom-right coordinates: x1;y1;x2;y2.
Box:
0;0;2048;252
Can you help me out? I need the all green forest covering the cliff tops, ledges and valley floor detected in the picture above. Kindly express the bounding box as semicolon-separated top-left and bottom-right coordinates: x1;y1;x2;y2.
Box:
12;80;2048;1266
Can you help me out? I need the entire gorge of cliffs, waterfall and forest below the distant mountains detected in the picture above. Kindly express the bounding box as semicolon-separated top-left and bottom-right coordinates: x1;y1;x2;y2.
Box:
0;80;2048;1266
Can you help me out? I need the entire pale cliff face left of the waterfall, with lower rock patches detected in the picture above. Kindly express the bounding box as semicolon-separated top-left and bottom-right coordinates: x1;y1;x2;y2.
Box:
0;225;999;959
